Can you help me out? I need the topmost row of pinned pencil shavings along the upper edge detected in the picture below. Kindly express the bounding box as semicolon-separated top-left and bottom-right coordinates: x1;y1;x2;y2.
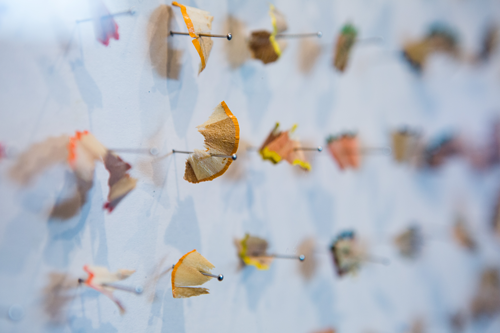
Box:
83;0;499;73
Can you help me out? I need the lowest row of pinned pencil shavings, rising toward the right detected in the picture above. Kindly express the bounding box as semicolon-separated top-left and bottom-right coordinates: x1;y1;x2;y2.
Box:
69;210;492;313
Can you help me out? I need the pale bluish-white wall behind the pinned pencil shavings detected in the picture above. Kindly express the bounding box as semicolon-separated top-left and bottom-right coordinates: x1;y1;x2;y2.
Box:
0;0;500;333
